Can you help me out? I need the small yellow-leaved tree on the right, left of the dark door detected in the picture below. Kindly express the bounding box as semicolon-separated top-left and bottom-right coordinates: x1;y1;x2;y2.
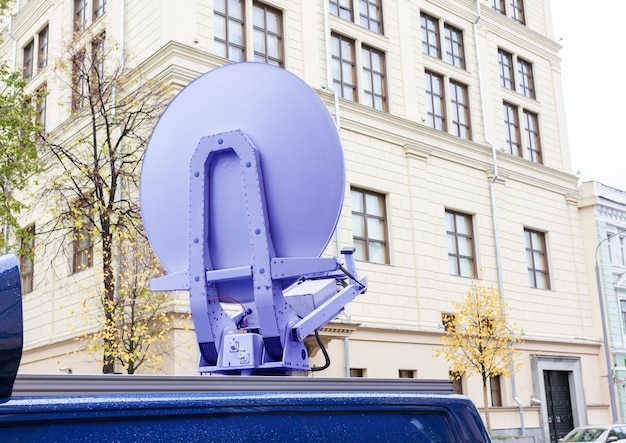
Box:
435;280;521;433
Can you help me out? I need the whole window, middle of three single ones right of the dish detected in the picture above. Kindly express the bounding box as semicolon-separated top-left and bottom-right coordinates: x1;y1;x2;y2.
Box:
446;210;477;278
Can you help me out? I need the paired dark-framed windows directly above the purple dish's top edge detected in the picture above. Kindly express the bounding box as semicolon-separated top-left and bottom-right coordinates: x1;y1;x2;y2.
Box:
213;0;284;67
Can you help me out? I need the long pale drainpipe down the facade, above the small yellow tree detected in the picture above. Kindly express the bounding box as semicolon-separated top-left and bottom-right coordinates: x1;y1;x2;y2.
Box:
473;0;526;435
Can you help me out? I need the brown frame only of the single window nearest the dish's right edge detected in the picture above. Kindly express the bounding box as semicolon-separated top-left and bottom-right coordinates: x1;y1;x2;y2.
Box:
350;187;389;264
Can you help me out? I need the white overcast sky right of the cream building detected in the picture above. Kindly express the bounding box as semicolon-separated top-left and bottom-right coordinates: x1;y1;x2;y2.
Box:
550;0;626;192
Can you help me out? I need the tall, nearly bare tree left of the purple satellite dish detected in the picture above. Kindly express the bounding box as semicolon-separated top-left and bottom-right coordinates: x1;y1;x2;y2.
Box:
39;31;169;373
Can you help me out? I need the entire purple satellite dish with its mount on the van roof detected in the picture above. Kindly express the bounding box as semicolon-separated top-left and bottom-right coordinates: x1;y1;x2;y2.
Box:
140;63;367;374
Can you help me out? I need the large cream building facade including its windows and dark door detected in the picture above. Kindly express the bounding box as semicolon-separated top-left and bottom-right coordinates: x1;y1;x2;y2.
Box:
2;0;610;442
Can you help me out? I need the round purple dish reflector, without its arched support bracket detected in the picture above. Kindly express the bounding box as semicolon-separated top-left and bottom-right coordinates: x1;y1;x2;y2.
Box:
140;63;345;273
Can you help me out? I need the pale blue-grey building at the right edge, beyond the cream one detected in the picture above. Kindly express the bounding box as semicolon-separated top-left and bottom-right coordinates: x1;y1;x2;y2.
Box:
579;181;626;422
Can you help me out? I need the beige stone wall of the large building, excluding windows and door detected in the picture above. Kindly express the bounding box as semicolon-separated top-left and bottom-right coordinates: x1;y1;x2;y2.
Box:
0;0;610;438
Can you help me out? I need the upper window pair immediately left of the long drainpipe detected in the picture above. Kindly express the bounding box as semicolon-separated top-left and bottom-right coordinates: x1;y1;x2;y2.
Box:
420;12;465;69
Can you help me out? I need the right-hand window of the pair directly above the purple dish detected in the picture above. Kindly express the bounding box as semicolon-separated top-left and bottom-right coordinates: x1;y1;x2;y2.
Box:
253;3;283;66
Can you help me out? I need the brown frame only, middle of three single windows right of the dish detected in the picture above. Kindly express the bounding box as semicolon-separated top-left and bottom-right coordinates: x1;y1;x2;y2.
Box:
445;209;478;278
